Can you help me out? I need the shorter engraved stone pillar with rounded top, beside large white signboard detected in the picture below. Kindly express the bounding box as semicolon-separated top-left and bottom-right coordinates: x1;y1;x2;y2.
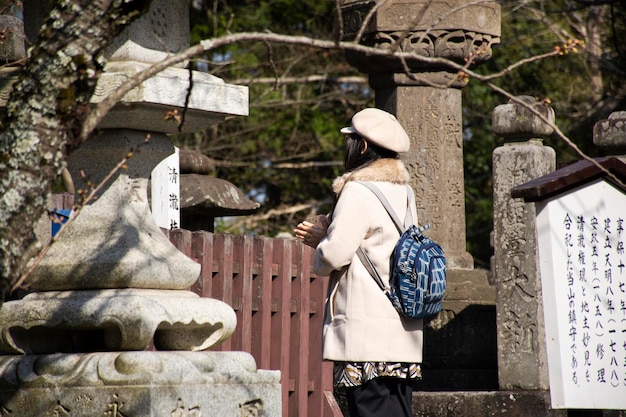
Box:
492;96;555;390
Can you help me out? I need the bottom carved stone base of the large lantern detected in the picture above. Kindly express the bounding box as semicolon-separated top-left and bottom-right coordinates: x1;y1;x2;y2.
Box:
0;352;281;417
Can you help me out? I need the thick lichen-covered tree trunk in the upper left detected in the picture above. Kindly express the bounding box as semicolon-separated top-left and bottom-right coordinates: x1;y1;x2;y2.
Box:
0;0;150;299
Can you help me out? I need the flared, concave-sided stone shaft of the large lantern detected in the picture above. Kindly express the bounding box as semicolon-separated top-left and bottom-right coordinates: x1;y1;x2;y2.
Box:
31;130;200;291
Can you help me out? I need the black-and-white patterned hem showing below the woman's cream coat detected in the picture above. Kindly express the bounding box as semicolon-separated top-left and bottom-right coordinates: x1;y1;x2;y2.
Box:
333;362;422;387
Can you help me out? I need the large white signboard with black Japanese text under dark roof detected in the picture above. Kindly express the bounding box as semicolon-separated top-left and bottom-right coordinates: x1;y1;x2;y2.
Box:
537;180;626;410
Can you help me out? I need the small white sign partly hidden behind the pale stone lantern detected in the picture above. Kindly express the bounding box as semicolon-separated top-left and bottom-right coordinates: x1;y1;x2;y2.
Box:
150;148;180;230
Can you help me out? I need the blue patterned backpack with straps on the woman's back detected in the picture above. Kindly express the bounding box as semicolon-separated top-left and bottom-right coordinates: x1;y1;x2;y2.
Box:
357;181;446;319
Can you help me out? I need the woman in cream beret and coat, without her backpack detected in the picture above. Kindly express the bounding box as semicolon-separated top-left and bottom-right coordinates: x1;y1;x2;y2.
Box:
295;108;423;417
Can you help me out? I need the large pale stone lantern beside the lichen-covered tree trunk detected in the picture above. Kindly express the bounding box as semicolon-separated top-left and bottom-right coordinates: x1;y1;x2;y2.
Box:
0;0;281;417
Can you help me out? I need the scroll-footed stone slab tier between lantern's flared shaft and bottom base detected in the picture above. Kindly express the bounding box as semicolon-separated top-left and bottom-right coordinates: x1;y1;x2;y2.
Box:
0;289;237;354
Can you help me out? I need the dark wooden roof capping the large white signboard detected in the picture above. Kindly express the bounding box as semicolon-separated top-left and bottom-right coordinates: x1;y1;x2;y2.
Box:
511;156;626;202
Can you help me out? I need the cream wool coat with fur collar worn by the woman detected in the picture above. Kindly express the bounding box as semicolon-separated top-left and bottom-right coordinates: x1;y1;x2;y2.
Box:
313;159;423;363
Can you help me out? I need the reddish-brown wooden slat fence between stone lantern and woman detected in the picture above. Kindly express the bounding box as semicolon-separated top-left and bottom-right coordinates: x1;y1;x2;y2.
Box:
165;230;341;417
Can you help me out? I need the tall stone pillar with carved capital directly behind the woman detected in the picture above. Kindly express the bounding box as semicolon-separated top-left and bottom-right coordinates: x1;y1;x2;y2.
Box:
342;0;500;269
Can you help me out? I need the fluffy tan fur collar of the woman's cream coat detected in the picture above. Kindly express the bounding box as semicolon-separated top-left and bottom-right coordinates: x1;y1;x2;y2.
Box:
333;158;410;194
